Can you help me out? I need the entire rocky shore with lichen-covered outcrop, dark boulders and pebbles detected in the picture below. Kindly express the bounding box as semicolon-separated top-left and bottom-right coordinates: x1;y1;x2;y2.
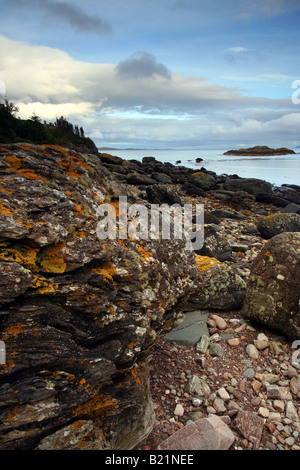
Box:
0;144;300;450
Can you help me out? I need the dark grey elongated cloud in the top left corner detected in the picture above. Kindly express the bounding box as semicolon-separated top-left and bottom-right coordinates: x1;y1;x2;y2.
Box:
2;0;112;34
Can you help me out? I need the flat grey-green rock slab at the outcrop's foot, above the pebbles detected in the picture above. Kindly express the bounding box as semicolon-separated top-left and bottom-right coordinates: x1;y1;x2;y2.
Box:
164;310;209;346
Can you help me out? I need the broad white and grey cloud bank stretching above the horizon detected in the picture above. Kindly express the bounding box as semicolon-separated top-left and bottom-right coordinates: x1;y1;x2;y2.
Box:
0;36;300;147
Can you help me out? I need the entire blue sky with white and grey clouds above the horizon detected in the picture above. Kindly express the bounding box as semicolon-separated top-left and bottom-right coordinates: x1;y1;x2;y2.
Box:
0;0;300;150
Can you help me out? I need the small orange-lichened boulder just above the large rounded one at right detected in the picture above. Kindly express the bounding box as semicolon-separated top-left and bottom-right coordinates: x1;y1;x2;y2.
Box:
257;212;300;239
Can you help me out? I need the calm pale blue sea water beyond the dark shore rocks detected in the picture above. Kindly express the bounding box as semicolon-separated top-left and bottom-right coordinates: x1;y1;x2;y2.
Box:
107;149;300;186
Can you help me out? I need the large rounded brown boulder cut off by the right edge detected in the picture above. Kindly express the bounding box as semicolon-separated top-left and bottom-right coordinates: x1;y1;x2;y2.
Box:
242;232;300;339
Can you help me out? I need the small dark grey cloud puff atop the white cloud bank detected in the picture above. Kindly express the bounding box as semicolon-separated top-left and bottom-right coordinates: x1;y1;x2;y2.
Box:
116;51;171;80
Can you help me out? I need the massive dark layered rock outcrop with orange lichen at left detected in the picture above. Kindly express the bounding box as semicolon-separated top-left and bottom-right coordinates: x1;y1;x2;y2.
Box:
0;144;245;450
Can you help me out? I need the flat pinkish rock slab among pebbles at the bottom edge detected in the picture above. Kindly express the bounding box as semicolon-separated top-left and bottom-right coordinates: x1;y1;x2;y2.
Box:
158;416;235;450
